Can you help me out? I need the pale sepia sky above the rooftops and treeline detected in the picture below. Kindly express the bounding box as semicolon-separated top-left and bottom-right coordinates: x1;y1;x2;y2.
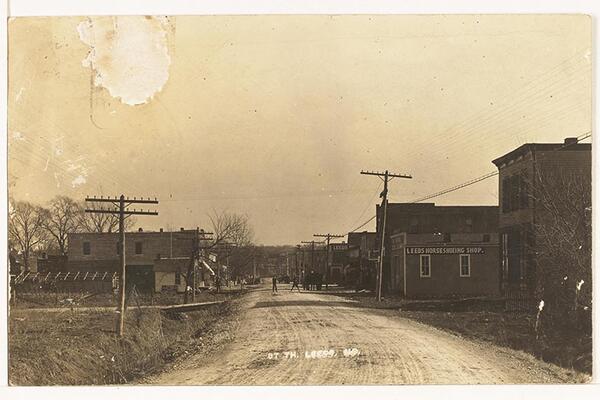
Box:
8;15;592;244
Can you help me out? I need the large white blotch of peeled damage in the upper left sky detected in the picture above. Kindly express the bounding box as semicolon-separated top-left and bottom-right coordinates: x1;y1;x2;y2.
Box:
77;16;171;105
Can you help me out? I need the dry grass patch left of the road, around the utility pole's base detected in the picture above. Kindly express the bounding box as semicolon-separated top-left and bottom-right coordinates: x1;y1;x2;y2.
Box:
9;292;243;386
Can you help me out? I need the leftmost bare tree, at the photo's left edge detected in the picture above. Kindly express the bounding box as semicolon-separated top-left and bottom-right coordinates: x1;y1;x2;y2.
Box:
8;201;48;271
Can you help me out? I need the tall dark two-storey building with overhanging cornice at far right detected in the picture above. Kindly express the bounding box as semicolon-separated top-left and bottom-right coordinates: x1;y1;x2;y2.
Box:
492;138;592;297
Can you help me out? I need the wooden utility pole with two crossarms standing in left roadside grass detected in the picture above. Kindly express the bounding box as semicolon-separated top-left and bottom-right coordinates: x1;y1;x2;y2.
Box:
85;194;158;336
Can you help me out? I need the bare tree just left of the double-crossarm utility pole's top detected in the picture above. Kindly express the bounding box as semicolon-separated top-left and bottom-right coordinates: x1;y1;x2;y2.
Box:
43;196;83;255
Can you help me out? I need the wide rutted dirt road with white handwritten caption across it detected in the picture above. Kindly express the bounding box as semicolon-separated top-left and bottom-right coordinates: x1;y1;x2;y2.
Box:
145;288;568;385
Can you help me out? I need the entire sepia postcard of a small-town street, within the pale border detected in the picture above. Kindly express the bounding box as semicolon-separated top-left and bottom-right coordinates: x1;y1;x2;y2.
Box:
6;14;593;386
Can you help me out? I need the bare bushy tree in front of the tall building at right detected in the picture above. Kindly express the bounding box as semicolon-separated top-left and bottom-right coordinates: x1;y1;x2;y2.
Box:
530;170;592;329
